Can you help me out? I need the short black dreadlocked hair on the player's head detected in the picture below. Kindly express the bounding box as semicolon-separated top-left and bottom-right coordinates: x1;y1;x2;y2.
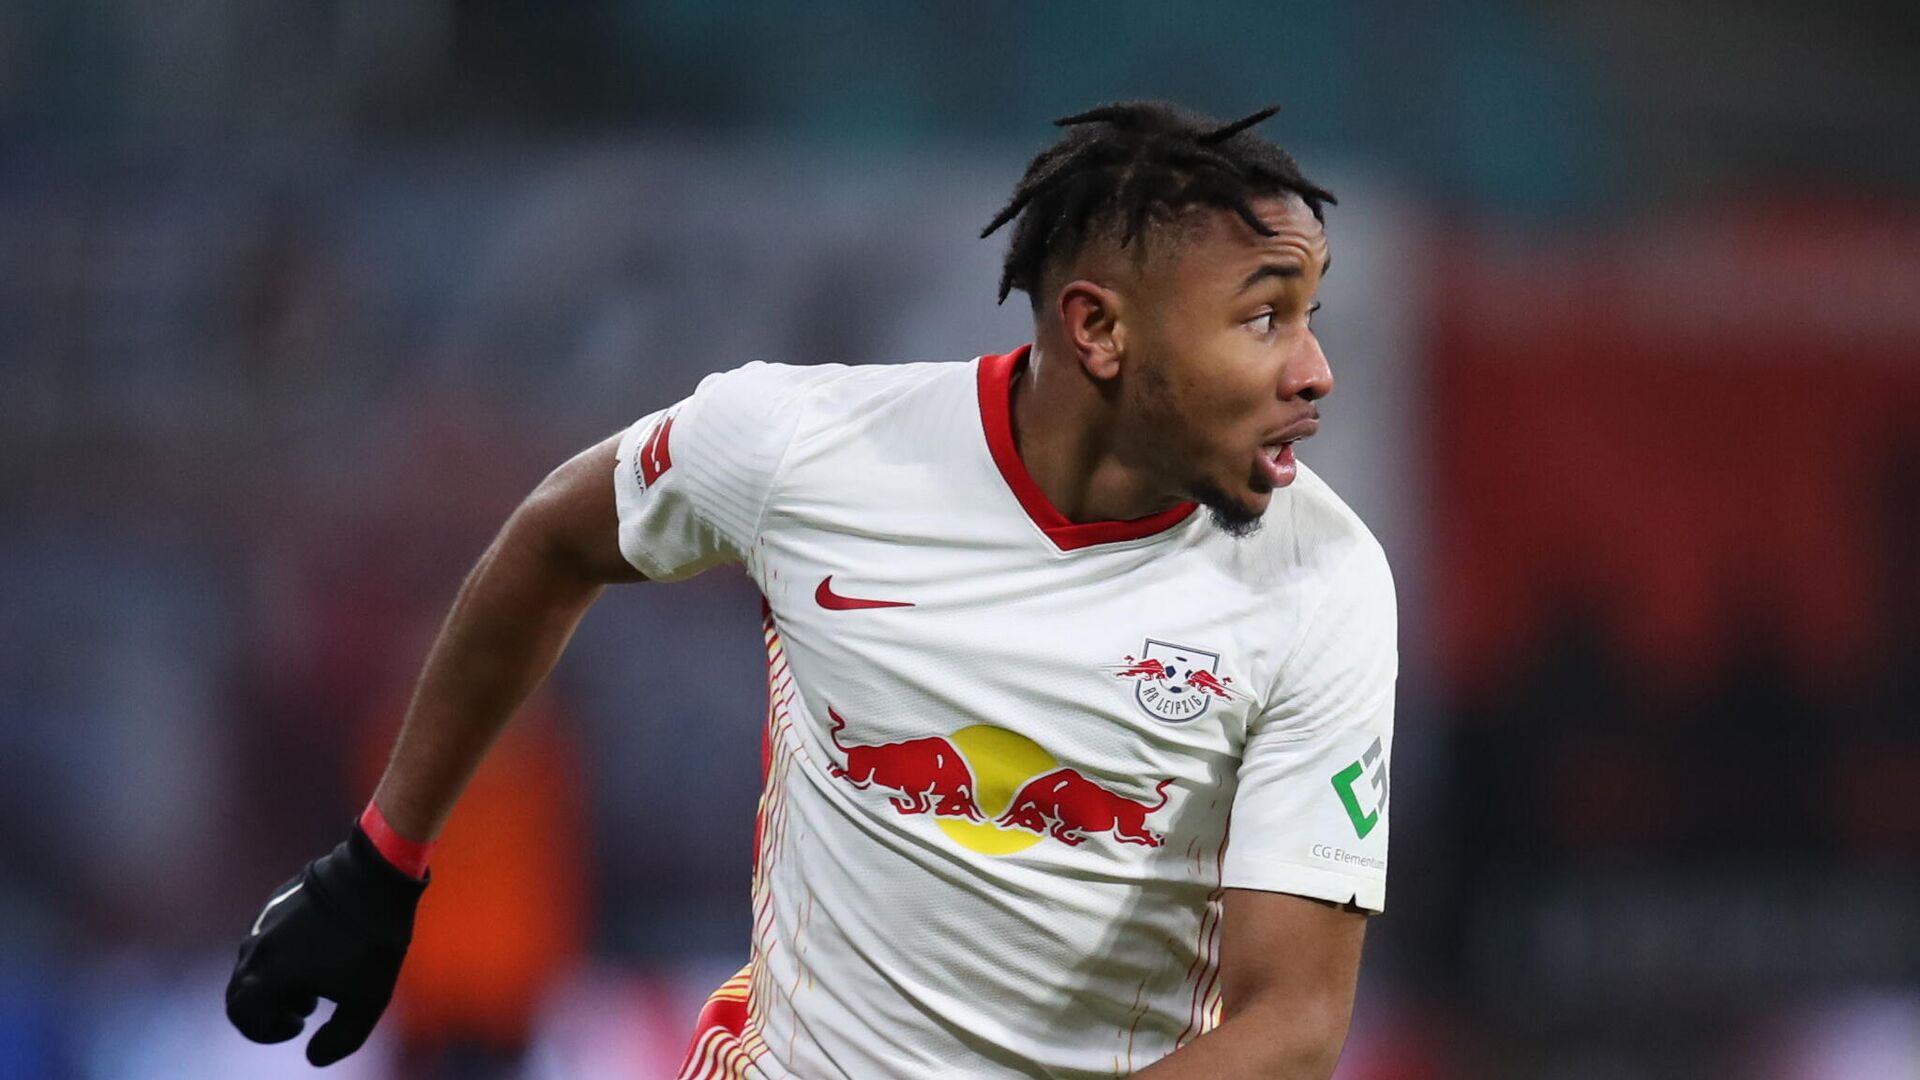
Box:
979;102;1338;304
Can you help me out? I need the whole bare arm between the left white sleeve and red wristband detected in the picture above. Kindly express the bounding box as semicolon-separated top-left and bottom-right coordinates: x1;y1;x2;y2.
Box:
374;434;645;842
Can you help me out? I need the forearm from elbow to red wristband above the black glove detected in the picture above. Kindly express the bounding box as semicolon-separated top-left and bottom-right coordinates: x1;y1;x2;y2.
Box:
374;502;603;842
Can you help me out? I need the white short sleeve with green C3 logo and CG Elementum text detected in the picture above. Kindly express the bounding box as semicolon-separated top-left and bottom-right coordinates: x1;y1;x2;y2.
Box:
1221;536;1400;913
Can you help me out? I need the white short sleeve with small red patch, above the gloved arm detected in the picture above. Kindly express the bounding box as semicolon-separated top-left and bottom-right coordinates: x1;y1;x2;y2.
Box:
612;361;820;580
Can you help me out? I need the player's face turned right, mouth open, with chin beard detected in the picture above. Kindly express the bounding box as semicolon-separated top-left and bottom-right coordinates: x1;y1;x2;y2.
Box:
1121;196;1332;536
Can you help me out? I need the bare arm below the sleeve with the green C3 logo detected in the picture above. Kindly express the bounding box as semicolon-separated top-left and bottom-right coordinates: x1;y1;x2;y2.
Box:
1137;890;1367;1080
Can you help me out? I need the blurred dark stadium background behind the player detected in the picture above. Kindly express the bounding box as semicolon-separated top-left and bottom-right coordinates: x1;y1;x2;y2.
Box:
0;0;1920;1080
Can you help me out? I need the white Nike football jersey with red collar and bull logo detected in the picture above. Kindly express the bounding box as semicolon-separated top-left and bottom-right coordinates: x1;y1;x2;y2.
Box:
614;348;1396;1078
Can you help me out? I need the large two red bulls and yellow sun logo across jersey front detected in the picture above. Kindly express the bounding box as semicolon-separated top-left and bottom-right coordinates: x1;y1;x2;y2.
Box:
828;709;1173;855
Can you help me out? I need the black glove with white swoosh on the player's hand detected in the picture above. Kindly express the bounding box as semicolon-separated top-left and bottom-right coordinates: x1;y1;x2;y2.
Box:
227;826;426;1065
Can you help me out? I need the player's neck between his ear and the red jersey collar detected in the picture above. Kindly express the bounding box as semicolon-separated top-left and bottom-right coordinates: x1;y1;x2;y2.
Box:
1012;342;1183;523
